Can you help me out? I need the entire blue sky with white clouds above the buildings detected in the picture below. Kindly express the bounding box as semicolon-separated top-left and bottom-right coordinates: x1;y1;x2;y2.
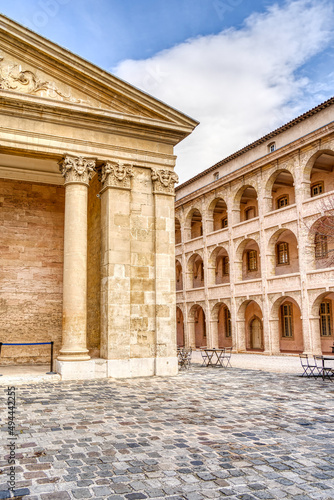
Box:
0;0;334;182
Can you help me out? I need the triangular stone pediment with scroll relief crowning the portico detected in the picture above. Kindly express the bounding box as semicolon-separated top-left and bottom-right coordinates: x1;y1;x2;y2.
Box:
0;15;197;129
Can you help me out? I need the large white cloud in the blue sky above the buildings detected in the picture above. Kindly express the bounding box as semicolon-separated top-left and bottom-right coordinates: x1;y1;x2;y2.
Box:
113;0;334;182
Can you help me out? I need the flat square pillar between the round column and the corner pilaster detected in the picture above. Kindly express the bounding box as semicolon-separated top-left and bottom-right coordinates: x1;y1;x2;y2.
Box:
100;161;133;378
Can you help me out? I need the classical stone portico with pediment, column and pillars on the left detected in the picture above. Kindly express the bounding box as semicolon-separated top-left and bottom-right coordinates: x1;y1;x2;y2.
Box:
0;16;197;379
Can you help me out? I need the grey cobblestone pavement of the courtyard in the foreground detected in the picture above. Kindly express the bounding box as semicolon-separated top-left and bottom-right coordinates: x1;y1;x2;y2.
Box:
0;367;334;500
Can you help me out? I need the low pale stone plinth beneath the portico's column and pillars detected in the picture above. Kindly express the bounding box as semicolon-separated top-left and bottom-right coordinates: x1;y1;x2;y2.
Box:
56;357;178;380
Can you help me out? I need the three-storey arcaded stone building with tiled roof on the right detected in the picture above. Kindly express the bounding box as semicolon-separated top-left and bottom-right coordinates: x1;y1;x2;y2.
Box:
175;98;334;355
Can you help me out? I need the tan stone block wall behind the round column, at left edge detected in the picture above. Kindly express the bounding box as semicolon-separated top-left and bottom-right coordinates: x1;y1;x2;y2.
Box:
0;179;64;364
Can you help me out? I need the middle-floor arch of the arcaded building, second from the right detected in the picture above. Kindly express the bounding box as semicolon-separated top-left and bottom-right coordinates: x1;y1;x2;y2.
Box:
267;229;299;276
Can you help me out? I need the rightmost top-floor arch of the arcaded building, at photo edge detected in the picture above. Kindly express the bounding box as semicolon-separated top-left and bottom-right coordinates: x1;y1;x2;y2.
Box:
309;152;334;198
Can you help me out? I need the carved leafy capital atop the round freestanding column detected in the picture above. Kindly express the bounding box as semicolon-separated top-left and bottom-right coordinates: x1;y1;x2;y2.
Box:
58;155;95;186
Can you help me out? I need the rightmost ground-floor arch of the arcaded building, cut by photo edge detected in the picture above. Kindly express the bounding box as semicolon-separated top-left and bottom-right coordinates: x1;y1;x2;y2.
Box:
311;292;334;354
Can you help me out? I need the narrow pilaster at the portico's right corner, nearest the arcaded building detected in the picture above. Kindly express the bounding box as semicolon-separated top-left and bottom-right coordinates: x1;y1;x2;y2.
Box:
151;168;178;375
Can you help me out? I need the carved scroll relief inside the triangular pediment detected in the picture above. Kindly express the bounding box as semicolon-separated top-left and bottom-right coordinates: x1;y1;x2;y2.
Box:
0;55;87;104
